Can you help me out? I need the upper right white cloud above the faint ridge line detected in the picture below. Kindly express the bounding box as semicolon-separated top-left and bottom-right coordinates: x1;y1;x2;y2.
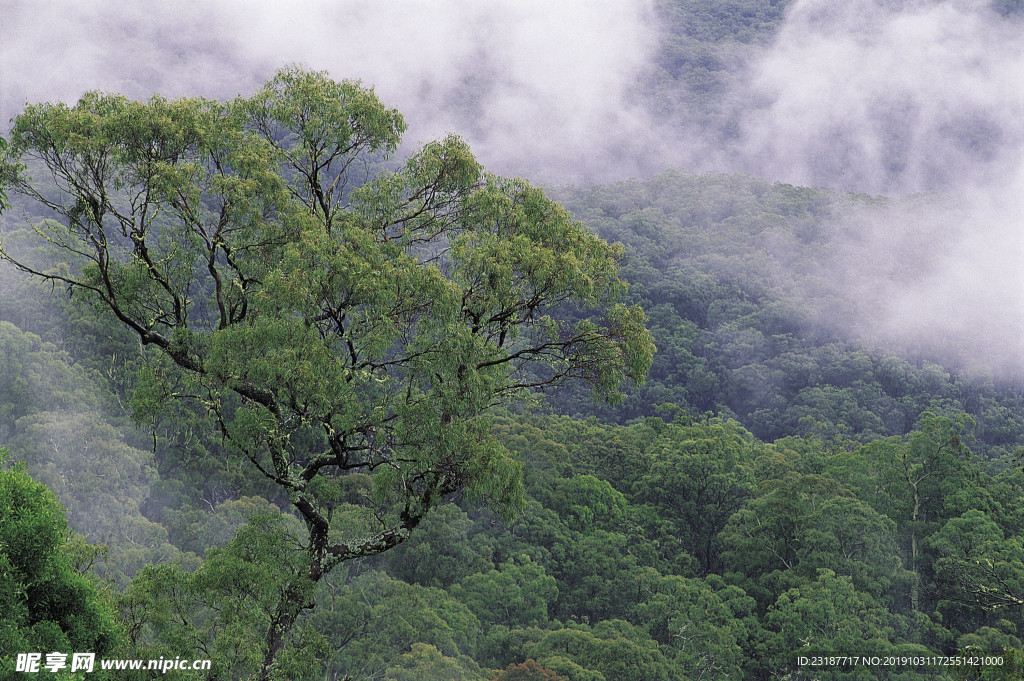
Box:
740;0;1024;194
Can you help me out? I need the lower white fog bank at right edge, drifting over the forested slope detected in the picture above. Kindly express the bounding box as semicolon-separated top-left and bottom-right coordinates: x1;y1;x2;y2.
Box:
793;180;1024;374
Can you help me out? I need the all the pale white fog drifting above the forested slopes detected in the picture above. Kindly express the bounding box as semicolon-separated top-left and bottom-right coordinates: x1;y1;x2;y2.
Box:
0;0;1024;369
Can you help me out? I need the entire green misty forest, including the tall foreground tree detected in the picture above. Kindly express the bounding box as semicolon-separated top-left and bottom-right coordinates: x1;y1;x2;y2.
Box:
0;0;1024;681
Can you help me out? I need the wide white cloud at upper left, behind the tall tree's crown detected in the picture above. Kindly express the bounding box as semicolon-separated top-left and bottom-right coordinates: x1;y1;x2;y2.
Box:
0;0;655;178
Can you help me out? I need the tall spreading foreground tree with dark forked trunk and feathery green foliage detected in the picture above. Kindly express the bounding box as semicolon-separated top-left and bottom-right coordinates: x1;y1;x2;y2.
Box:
0;68;654;679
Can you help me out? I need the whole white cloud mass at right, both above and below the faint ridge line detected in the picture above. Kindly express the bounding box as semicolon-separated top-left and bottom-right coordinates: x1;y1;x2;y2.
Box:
733;0;1024;372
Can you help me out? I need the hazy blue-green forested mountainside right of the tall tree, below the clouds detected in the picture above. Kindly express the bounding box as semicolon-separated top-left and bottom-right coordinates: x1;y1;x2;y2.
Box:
552;173;1024;459
